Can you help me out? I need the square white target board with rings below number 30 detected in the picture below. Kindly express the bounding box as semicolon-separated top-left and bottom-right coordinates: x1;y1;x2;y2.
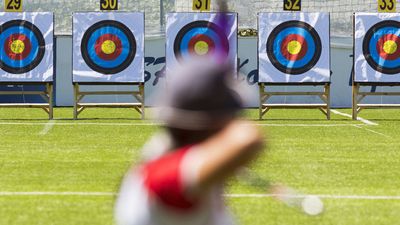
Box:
72;12;144;83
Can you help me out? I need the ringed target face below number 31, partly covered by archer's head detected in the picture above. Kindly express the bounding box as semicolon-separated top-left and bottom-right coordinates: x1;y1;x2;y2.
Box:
174;21;229;62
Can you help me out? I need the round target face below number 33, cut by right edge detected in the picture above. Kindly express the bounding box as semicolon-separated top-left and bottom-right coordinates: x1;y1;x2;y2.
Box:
362;20;400;74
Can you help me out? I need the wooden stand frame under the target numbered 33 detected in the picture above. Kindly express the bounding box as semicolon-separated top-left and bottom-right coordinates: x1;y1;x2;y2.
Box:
352;82;400;120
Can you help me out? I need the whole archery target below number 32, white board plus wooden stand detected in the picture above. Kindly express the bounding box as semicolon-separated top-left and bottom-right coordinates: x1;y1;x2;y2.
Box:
258;13;331;120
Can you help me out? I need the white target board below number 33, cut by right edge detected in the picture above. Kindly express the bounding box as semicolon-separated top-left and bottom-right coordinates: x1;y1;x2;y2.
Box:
354;13;400;83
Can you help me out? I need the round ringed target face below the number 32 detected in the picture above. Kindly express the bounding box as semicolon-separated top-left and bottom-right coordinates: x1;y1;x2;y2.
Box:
267;20;322;75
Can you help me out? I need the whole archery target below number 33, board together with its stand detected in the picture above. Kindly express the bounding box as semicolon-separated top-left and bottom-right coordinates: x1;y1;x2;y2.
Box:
352;13;400;120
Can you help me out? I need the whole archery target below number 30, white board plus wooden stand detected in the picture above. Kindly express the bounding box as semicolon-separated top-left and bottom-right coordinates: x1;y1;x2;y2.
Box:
73;12;145;119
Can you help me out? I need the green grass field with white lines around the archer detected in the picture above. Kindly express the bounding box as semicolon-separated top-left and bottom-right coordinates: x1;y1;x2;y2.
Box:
0;108;400;225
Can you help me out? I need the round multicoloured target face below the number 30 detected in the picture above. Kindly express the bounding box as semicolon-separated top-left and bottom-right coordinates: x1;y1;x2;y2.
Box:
81;20;136;75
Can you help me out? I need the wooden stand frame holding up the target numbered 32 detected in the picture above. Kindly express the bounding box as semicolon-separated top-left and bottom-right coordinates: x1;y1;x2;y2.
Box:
259;82;331;120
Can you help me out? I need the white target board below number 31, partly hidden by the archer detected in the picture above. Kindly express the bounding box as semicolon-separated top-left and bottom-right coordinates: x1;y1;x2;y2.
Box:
166;13;237;74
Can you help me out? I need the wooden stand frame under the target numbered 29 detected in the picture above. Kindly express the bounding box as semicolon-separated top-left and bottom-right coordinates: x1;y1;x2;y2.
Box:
0;82;53;120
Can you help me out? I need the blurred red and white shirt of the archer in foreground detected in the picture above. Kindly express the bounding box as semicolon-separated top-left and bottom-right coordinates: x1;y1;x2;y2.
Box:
115;147;234;225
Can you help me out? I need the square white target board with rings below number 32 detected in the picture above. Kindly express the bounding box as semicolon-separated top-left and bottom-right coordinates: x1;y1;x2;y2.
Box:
258;12;330;83
